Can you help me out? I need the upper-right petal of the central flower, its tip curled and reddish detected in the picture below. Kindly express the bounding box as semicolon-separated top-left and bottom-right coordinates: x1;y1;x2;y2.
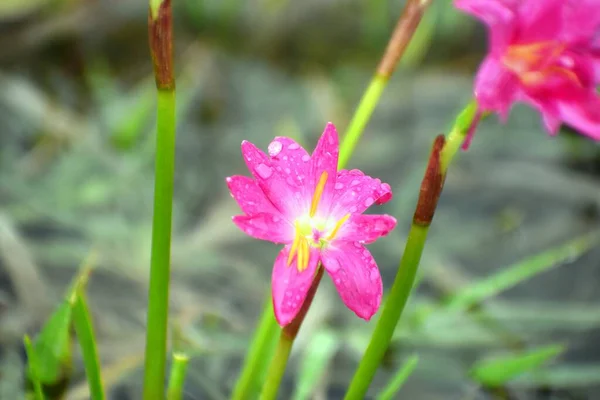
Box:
330;169;392;218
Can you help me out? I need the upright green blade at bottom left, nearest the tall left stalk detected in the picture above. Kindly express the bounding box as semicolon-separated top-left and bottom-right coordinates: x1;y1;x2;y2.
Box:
73;290;105;400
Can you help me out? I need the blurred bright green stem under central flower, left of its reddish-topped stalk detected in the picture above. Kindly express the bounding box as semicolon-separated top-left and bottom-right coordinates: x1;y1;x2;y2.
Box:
232;293;279;400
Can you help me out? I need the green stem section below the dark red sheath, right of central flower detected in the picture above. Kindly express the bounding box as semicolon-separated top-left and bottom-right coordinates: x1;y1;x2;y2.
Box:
344;224;429;400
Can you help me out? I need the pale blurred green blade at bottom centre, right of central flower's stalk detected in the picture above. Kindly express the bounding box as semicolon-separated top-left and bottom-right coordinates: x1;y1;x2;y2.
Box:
292;330;339;400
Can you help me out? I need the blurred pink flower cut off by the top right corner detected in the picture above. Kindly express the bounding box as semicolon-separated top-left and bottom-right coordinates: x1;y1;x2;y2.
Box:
455;0;600;140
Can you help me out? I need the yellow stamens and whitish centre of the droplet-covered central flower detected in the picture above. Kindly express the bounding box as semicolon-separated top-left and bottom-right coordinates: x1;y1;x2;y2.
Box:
287;171;350;272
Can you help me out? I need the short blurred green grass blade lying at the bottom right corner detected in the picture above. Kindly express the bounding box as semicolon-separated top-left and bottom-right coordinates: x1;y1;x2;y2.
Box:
470;344;565;387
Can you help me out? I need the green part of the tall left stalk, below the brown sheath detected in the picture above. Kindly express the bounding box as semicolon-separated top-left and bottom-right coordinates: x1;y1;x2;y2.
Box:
144;88;175;400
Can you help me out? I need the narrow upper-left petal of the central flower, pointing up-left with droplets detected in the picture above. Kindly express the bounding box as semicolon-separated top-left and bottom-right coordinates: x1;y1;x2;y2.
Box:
242;141;310;220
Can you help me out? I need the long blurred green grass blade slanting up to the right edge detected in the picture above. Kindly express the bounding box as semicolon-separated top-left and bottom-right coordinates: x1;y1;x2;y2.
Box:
446;232;599;310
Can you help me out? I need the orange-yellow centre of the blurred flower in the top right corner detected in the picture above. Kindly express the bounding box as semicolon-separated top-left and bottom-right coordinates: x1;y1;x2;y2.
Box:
502;41;582;86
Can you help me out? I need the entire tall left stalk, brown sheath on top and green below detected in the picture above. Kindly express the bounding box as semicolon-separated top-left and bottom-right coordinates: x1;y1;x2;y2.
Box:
143;0;175;400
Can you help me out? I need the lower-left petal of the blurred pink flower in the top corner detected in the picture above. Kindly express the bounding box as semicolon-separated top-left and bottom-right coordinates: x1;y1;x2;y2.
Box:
475;56;520;120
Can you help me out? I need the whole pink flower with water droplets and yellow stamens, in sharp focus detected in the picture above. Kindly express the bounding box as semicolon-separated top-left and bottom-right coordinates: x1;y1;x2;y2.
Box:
227;123;396;326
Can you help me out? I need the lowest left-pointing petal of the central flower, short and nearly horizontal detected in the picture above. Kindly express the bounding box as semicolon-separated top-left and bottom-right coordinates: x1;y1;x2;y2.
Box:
232;212;294;243
